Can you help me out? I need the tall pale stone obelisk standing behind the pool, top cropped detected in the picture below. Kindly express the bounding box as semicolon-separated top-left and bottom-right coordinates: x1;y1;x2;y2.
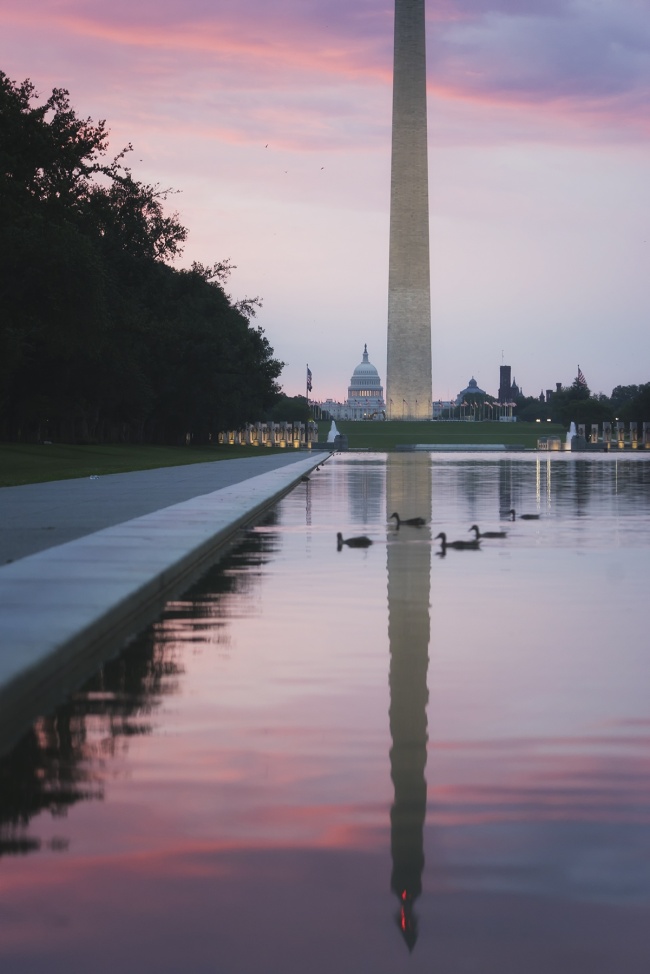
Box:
386;0;431;420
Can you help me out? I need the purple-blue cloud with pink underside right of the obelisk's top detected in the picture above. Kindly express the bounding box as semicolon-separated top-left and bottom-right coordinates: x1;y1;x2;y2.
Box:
429;0;650;122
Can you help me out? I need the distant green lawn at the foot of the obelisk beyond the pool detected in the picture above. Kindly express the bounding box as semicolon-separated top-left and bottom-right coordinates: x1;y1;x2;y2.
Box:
318;420;566;452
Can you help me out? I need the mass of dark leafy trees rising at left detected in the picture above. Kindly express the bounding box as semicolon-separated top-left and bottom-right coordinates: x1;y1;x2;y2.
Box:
0;72;284;443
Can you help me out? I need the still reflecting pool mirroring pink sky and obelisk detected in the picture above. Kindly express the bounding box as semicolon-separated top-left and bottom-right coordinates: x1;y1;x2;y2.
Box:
0;454;650;974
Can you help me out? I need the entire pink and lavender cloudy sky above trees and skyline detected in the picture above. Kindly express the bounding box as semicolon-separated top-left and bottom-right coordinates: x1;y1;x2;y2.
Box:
0;0;650;399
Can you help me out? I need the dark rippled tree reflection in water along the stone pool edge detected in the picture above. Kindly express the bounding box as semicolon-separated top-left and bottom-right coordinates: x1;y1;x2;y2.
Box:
0;517;277;856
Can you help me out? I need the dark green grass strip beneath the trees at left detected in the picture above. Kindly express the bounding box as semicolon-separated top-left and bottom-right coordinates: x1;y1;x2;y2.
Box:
0;443;286;487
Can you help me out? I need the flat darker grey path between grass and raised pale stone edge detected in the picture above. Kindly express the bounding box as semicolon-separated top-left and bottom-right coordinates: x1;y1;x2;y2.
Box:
0;450;312;566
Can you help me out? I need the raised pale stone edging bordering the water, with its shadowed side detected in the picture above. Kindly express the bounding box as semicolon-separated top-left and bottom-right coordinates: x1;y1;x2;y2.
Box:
0;452;324;753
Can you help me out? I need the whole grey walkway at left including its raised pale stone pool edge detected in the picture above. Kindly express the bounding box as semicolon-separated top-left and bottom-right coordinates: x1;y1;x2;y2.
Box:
0;451;327;753
